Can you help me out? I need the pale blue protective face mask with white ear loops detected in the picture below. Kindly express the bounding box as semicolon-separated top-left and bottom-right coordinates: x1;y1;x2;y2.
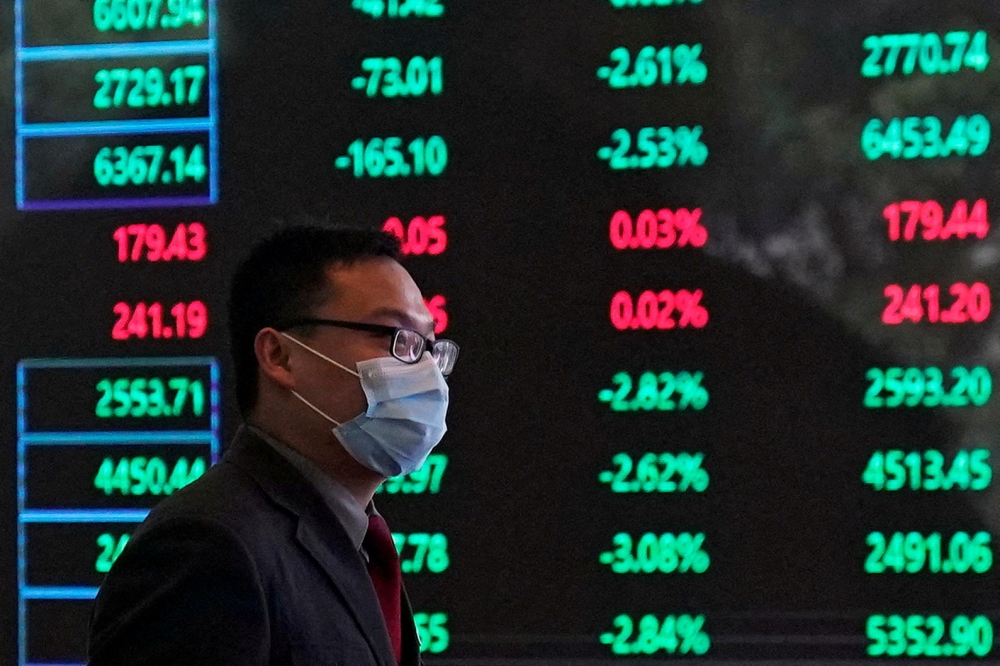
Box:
282;333;448;476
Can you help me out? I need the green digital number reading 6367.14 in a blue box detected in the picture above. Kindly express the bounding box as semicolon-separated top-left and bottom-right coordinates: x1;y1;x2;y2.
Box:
94;144;208;187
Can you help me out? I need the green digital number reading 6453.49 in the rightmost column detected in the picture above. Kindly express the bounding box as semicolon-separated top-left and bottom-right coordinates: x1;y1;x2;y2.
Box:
861;114;991;161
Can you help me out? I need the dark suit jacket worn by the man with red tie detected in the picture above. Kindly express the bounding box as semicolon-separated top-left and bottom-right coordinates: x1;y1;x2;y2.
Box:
89;429;420;666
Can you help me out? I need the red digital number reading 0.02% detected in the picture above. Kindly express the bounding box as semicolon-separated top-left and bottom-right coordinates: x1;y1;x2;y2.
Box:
611;289;708;331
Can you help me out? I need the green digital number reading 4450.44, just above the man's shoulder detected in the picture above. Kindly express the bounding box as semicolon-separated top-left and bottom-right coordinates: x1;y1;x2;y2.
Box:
94;456;206;496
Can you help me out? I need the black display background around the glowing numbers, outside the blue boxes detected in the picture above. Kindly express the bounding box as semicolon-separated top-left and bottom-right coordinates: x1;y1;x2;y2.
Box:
0;0;1000;663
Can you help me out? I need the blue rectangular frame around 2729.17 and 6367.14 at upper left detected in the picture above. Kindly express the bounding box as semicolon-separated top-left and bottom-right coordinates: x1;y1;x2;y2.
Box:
14;0;221;211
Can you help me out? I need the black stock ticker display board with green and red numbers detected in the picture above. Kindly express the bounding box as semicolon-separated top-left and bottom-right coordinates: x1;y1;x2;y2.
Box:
0;0;1000;666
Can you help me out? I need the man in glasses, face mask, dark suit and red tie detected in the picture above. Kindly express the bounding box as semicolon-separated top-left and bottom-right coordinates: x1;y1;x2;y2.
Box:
89;227;458;666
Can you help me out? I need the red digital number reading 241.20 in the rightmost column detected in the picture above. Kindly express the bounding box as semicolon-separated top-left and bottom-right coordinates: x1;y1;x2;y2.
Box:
882;282;991;326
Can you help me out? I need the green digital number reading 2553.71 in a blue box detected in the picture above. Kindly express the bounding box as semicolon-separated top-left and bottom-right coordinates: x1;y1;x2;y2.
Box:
94;377;206;419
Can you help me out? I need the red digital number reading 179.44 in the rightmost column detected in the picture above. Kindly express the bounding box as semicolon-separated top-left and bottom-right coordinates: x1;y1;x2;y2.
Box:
882;199;990;241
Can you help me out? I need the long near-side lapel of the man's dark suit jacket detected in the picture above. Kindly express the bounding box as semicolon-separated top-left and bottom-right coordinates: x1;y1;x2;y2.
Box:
225;428;398;666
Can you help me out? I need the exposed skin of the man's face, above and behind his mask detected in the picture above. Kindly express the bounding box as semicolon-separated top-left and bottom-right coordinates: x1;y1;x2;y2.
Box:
287;257;434;428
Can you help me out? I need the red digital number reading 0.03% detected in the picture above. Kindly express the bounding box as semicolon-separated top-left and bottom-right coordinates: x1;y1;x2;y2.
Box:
610;208;708;250
